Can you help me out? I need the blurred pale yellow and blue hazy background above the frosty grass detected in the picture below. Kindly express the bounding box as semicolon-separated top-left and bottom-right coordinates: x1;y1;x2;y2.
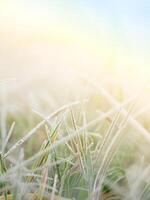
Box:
0;0;150;119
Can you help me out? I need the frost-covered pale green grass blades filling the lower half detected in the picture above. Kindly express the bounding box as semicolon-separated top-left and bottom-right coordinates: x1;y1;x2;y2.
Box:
0;79;150;200
